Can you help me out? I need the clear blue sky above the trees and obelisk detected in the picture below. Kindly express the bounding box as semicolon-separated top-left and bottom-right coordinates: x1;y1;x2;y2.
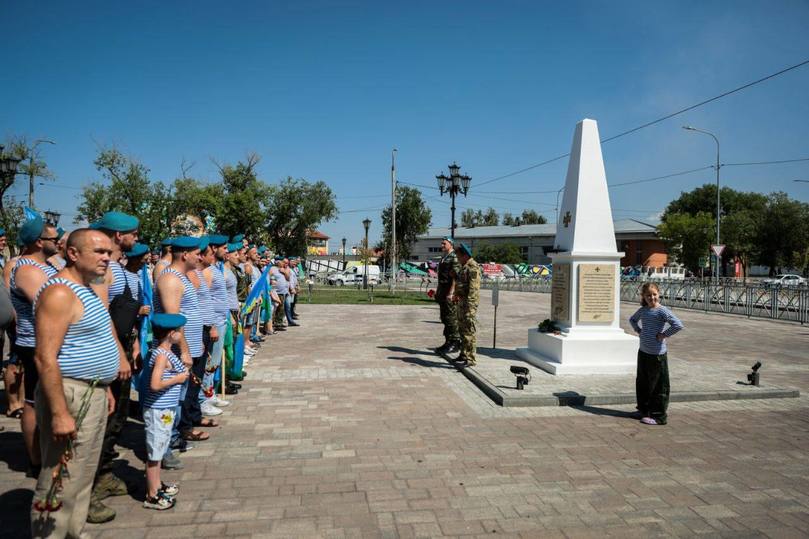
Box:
0;0;809;248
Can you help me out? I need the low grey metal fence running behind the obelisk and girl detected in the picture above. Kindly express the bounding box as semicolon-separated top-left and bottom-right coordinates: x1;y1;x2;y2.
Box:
481;279;809;324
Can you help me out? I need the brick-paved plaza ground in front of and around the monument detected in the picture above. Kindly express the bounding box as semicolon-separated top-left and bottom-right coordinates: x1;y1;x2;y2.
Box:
0;293;809;538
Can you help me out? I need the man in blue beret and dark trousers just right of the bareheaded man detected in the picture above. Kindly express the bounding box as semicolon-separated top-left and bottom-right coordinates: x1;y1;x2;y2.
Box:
87;211;140;524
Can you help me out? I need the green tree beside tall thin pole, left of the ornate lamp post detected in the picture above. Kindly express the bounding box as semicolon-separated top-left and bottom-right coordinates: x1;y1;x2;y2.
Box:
382;187;433;263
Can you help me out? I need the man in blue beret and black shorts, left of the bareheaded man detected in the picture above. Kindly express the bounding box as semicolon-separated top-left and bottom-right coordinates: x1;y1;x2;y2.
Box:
9;216;56;477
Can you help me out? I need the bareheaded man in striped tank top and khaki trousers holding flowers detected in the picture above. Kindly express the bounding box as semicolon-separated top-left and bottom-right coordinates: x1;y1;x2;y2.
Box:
31;229;126;537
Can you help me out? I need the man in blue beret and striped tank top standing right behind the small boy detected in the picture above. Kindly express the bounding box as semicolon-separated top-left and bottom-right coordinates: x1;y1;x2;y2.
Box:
155;236;210;448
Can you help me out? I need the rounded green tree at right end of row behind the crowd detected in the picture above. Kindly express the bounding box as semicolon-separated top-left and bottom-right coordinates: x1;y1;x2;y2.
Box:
264;178;337;255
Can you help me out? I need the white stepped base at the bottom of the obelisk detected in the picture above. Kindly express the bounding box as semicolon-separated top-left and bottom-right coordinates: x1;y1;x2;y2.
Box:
517;328;639;374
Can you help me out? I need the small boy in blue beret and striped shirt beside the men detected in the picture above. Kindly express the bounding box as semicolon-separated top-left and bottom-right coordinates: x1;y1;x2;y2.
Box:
143;313;189;511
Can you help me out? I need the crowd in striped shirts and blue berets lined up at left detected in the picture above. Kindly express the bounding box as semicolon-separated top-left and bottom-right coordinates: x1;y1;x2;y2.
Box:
0;212;300;537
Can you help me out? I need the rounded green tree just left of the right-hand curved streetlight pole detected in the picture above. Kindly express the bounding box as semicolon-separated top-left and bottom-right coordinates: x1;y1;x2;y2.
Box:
657;212;716;271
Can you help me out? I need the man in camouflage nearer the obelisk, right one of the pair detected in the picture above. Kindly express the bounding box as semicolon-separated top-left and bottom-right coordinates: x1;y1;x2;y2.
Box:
454;243;480;367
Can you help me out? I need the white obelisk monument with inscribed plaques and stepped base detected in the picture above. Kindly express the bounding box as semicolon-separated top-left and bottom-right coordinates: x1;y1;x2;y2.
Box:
517;119;638;374
